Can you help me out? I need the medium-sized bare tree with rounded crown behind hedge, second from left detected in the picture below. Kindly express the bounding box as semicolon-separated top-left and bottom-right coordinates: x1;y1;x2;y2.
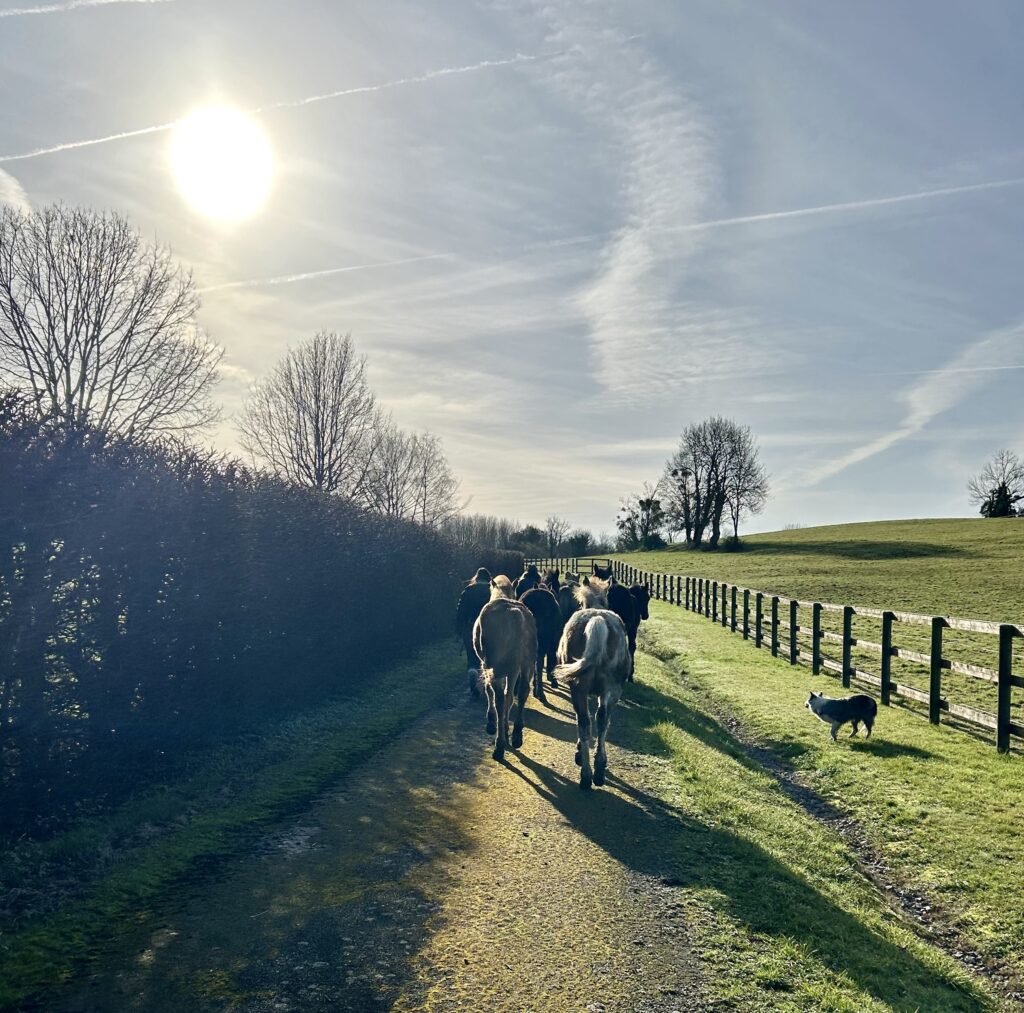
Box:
239;332;387;499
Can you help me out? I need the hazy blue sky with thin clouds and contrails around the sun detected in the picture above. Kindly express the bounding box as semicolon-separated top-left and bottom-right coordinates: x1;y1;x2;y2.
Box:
0;0;1024;531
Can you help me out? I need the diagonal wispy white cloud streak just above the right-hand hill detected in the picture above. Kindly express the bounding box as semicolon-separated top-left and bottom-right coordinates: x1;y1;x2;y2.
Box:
802;325;1024;486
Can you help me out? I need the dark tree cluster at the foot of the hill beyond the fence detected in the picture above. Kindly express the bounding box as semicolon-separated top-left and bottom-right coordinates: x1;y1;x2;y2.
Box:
616;416;768;551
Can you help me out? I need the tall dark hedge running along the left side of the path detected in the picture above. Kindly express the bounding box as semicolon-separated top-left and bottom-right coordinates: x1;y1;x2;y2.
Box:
0;398;474;832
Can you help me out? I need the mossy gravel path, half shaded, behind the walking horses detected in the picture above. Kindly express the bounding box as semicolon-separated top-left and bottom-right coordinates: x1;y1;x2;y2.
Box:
54;691;700;1013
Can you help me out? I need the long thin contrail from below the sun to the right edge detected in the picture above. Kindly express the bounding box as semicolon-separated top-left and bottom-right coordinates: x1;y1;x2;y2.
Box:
197;174;1024;290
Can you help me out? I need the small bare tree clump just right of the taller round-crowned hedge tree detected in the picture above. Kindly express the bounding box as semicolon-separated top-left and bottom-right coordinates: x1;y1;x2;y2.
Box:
360;421;459;527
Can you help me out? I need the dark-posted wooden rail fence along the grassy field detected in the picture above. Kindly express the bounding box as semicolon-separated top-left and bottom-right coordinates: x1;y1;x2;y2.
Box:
527;556;1024;753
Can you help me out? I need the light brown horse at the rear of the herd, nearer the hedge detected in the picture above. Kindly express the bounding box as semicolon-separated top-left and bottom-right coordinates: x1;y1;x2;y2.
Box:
473;581;537;760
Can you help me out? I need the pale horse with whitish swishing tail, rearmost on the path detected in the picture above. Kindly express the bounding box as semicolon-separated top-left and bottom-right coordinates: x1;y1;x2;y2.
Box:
555;608;630;790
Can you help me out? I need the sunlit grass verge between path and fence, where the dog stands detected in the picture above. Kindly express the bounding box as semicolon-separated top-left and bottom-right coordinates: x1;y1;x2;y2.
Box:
637;603;1024;1009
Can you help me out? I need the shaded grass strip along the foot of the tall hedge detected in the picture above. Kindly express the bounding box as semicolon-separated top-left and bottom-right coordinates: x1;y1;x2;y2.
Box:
0;643;461;1009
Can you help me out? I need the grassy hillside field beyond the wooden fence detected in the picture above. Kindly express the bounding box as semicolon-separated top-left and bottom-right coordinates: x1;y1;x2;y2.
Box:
618;518;1024;737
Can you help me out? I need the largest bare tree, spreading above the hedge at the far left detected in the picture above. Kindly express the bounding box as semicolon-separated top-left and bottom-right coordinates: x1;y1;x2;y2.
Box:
0;205;222;434
